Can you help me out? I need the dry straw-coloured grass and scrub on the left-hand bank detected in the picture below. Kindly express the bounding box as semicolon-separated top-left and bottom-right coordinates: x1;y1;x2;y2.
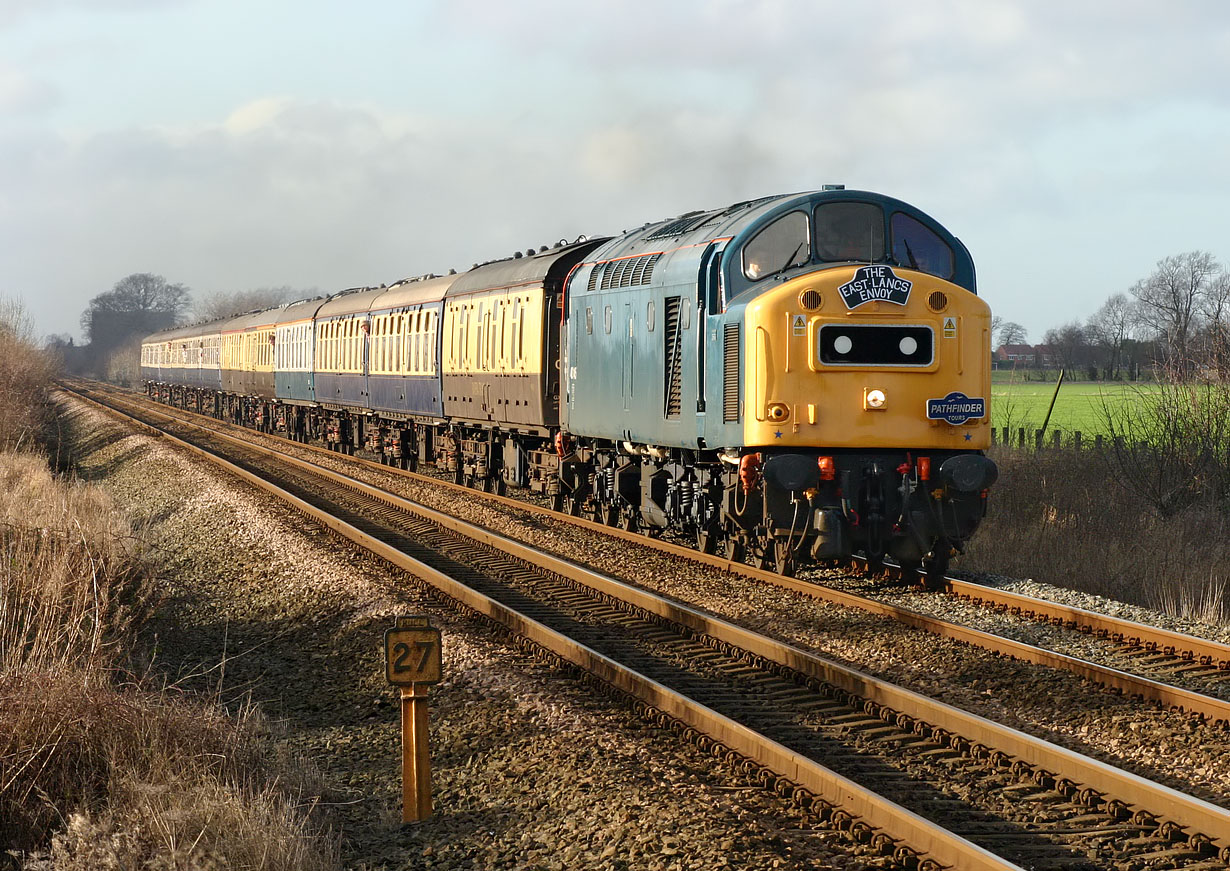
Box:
0;310;337;871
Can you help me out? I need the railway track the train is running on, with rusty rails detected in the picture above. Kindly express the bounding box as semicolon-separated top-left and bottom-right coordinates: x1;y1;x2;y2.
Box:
71;389;1230;726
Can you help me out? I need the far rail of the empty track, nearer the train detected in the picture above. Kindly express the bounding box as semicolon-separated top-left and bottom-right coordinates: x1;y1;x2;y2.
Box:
69;388;1230;857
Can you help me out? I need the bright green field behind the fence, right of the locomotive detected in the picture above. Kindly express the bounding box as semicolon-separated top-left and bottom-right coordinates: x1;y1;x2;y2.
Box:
991;381;1157;438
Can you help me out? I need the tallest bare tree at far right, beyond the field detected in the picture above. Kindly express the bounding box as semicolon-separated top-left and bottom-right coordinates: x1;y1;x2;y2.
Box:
1132;251;1221;373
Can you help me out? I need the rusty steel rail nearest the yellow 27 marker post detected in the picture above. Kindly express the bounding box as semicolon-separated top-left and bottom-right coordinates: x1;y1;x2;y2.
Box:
67;391;1022;871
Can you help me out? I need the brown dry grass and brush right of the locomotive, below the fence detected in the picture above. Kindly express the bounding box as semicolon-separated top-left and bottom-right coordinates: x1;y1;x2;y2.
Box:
962;448;1230;621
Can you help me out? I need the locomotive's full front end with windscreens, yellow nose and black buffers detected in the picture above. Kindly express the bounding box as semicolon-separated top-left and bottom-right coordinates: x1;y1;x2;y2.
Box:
726;194;998;579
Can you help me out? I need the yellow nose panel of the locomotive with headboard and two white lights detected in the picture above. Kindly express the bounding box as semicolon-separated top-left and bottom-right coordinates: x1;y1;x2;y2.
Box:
744;266;990;450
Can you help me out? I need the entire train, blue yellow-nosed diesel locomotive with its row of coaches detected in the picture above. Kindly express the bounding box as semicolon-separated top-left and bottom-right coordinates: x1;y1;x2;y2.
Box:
141;187;998;578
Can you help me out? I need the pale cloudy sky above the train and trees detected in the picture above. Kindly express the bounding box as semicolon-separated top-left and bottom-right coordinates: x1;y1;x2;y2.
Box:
0;0;1230;341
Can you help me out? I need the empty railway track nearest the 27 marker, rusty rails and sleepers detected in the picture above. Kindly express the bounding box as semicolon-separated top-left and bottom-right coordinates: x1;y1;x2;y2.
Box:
62;383;1230;869
